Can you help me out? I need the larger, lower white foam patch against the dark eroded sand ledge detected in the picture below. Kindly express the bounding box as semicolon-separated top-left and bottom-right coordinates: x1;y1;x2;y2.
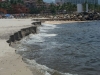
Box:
21;33;57;44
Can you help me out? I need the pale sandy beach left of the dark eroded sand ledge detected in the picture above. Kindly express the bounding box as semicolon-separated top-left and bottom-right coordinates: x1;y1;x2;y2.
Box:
0;19;33;75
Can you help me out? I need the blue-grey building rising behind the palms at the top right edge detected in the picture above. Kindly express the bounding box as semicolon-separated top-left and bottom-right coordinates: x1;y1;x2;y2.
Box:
55;0;99;4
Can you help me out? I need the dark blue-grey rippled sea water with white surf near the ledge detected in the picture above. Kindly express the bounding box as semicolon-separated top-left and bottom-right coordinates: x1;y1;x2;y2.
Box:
17;21;100;75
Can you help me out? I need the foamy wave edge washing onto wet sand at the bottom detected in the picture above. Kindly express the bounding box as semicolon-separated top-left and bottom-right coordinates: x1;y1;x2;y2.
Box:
23;58;77;75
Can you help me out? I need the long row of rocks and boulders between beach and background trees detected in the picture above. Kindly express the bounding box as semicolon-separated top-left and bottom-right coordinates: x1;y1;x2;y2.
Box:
32;12;100;22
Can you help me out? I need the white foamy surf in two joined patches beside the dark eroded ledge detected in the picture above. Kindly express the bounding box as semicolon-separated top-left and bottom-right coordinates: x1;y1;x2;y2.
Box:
21;24;57;44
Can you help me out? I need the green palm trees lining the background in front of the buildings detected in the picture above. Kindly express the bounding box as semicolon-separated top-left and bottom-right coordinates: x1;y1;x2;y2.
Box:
0;0;100;14
